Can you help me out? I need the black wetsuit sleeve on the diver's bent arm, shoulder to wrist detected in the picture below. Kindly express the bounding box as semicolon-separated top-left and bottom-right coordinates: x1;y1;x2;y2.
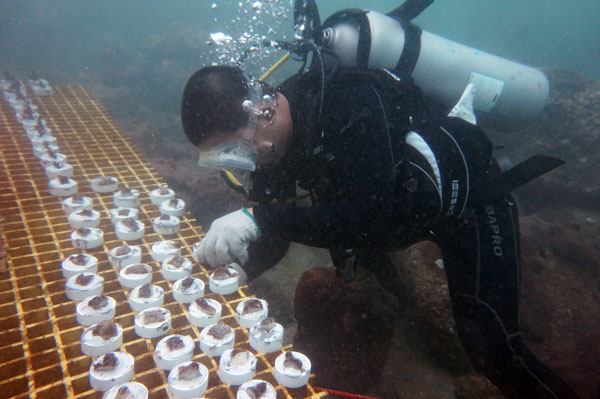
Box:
254;85;394;248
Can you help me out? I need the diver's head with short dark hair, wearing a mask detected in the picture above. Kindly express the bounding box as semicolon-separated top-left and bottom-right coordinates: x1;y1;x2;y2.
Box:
181;66;292;170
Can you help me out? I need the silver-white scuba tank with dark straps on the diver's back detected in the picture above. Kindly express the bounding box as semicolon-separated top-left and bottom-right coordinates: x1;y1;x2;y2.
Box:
317;7;549;131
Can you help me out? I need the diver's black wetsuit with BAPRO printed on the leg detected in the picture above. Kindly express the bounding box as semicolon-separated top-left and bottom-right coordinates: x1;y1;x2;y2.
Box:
247;70;577;398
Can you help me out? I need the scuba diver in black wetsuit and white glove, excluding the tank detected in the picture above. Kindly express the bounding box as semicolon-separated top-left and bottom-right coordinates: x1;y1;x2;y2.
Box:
181;0;578;398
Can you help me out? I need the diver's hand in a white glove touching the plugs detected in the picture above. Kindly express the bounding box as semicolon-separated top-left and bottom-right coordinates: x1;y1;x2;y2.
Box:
195;208;260;268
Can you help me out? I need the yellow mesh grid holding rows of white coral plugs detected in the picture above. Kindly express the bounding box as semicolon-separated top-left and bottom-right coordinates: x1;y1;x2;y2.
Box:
0;86;326;399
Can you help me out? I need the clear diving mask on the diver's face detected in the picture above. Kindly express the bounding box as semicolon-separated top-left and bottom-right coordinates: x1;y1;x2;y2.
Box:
198;77;277;172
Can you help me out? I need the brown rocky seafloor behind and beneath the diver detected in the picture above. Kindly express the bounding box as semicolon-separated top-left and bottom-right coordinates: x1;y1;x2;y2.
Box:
110;70;600;399
